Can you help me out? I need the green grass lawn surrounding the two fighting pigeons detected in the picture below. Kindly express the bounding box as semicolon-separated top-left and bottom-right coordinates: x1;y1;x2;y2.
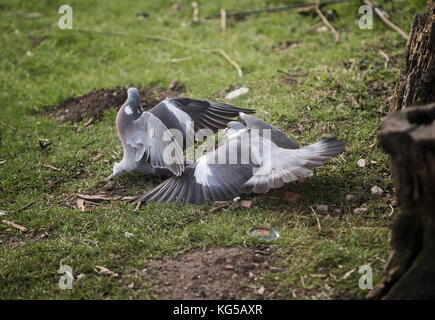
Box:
0;0;426;299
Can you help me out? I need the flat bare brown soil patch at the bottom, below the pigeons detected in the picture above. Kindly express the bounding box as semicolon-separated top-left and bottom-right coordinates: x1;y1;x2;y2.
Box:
141;247;279;299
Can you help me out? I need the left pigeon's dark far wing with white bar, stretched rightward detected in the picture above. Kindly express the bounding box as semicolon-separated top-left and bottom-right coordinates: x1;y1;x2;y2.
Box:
149;98;255;135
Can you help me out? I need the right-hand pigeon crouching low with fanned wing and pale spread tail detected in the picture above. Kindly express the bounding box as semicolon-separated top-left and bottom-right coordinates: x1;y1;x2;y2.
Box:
134;121;345;204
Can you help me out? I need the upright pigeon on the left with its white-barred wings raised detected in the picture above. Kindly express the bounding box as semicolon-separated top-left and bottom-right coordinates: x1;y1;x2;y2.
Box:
108;88;254;179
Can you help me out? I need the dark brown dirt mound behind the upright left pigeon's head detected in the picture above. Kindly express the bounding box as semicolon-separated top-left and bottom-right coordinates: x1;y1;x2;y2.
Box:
46;84;184;122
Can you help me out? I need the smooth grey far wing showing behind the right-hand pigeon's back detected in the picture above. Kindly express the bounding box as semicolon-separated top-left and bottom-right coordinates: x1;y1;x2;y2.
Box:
239;112;299;149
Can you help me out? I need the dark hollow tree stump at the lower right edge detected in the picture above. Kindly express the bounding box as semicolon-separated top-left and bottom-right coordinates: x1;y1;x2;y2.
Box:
367;103;435;299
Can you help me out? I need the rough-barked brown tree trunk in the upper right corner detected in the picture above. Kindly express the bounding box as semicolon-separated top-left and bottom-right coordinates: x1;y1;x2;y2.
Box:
390;0;435;113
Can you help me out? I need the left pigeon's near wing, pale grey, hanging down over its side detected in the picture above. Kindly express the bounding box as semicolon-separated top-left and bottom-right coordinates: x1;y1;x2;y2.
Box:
126;112;184;176
